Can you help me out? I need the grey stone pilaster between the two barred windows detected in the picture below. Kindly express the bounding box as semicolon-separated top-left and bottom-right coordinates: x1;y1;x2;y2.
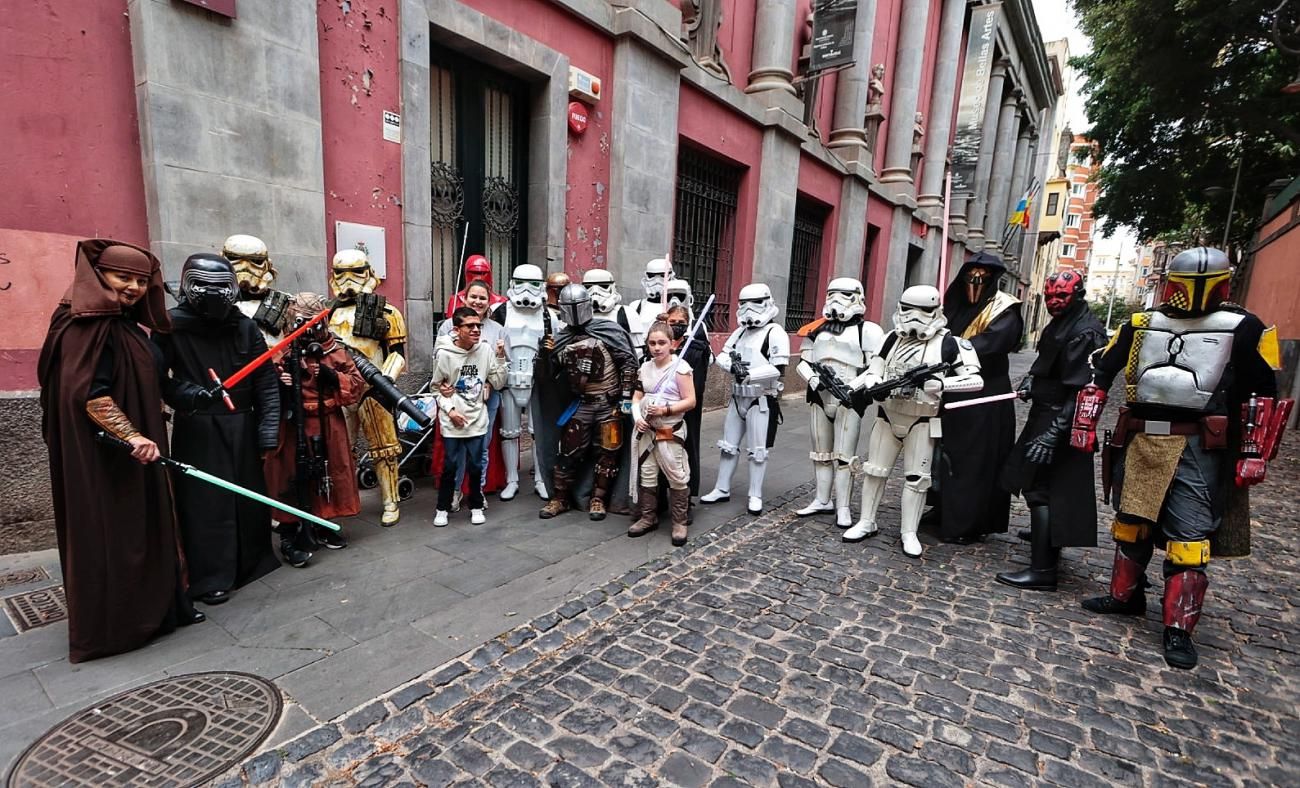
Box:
754;132;801;322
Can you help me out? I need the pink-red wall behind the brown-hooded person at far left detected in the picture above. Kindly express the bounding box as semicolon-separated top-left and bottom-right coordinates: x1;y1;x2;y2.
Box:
0;0;150;391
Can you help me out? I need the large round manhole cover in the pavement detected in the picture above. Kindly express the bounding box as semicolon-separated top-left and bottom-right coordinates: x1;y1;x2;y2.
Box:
8;672;281;788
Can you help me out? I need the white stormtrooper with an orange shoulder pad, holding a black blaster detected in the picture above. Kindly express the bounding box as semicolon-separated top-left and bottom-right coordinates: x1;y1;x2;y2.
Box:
796;278;884;528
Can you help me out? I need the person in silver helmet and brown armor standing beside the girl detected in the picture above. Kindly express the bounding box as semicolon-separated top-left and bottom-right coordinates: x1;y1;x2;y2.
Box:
538;285;637;520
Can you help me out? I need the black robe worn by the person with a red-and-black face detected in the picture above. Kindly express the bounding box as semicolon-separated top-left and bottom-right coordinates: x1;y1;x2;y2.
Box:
1002;298;1106;547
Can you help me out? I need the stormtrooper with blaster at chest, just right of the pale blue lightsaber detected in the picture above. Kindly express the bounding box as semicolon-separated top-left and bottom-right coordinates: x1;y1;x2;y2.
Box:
702;287;790;515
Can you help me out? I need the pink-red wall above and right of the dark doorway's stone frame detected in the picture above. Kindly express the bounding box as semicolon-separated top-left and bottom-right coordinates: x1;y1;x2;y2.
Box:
464;0;619;276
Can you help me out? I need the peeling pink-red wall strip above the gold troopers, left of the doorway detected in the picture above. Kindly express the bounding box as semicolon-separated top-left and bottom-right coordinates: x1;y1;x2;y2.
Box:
316;0;406;303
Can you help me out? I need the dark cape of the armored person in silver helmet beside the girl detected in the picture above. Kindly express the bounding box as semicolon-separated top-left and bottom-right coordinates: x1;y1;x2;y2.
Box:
532;318;640;514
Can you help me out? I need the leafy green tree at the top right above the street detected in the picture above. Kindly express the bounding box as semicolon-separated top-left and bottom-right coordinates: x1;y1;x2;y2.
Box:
1073;0;1300;246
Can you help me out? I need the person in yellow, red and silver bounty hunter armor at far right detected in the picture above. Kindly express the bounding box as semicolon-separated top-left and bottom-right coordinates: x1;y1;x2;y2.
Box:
1070;247;1292;670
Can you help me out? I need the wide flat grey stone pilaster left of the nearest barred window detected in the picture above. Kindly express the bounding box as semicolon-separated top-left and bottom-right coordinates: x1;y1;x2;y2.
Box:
606;36;686;287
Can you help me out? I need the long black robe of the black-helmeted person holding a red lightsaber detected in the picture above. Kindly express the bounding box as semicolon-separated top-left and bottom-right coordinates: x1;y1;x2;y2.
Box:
153;304;280;597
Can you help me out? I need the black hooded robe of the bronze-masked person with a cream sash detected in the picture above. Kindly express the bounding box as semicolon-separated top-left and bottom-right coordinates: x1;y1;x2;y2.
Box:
935;255;1024;538
